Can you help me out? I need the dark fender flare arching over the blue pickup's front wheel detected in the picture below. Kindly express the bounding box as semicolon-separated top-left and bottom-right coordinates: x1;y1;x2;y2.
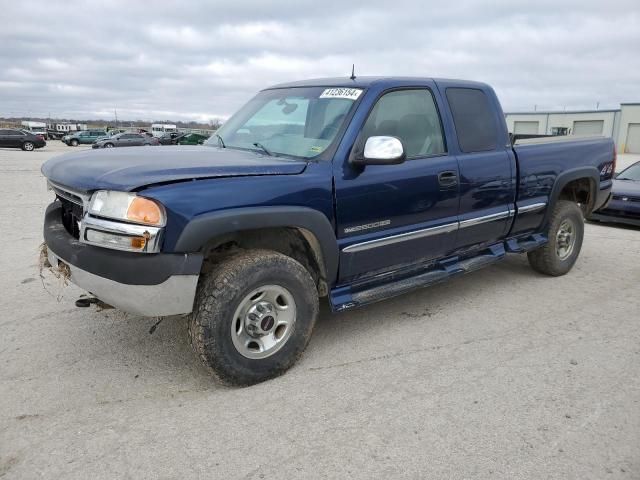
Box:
174;206;339;285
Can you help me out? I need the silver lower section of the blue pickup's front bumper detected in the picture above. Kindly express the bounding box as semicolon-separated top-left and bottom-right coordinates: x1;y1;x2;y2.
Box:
48;249;199;317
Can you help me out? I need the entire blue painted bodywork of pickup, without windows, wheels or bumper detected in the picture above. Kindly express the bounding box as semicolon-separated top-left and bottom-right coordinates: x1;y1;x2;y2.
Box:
42;77;615;310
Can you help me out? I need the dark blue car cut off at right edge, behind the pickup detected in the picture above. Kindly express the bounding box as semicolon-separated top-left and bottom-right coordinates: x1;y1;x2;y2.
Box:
589;162;640;226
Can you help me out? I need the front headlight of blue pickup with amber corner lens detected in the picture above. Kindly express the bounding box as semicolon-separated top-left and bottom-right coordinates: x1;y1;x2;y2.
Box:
89;190;167;227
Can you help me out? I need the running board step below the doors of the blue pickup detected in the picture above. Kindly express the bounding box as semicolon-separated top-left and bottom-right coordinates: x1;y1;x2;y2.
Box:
329;243;506;312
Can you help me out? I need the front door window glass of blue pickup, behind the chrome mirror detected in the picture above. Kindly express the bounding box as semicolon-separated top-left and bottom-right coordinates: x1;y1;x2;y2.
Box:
362;89;446;159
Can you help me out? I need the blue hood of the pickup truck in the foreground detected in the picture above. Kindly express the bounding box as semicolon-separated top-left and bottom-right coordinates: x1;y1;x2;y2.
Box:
42;146;307;191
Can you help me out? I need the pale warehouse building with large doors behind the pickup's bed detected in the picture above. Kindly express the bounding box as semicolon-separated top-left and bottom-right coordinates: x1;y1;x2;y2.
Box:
505;103;640;153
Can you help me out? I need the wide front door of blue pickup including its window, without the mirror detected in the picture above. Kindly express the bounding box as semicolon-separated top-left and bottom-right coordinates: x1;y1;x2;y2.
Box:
334;85;458;282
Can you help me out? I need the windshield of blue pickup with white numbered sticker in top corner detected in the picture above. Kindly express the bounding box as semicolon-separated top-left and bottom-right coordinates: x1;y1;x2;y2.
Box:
205;87;362;158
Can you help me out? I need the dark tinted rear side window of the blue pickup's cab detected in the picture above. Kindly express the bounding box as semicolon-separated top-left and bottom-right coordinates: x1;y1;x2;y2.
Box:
446;87;498;153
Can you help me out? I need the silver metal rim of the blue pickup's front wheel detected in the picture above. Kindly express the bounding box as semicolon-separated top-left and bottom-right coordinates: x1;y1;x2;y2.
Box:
231;285;296;359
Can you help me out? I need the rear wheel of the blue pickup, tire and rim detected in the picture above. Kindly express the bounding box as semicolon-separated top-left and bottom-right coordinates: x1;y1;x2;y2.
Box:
527;200;584;277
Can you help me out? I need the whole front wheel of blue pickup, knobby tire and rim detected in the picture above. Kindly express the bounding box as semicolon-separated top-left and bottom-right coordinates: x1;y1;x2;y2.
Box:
188;250;318;386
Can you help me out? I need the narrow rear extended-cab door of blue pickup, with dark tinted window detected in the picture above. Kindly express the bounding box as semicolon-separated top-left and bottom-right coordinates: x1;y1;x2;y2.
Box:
445;87;516;249
